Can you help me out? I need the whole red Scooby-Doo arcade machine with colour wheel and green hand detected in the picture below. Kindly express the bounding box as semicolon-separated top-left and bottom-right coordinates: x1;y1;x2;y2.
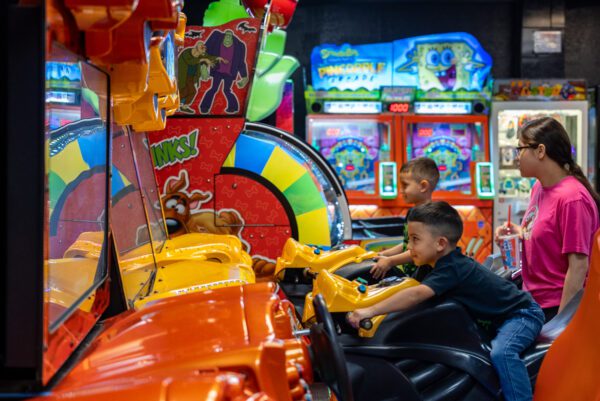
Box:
149;1;350;279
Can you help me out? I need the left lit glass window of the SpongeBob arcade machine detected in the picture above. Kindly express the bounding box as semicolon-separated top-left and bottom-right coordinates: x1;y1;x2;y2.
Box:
310;119;391;194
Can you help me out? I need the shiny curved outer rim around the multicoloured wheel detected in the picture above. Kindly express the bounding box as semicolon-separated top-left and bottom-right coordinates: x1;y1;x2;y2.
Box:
244;131;344;245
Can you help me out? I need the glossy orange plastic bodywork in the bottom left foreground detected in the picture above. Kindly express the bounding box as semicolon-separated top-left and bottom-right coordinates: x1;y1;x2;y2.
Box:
37;283;312;401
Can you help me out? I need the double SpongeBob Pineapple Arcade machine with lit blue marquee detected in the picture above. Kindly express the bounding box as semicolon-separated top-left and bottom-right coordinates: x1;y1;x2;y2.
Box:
306;33;494;261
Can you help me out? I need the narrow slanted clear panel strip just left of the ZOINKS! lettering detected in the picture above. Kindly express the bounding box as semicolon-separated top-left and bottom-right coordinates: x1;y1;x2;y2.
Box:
131;132;167;252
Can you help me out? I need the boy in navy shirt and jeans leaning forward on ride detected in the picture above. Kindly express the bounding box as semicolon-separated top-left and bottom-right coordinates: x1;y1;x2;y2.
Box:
348;202;544;401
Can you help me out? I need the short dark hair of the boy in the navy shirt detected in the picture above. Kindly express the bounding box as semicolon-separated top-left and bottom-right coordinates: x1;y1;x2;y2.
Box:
406;201;463;245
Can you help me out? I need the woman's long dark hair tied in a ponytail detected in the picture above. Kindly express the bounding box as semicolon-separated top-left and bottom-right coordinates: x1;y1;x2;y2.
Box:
518;117;600;211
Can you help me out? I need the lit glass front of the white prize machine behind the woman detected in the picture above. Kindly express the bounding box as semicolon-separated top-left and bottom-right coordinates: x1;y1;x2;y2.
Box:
498;110;582;198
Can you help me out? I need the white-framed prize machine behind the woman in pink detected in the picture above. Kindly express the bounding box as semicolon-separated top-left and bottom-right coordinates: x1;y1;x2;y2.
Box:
490;80;595;239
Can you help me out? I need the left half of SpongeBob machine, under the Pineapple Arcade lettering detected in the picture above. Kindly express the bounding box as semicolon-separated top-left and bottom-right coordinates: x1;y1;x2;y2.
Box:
305;43;404;249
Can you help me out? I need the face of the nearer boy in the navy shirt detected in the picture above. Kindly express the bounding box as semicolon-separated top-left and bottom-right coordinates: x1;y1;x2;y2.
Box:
408;221;445;266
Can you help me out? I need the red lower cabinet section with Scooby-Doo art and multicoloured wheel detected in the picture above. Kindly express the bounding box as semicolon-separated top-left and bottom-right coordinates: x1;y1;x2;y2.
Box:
149;118;349;276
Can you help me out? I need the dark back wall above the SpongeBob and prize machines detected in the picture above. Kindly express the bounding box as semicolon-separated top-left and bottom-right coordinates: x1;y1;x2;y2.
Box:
286;0;600;137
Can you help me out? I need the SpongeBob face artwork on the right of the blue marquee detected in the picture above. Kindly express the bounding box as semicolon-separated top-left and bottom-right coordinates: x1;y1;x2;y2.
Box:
395;35;491;91
